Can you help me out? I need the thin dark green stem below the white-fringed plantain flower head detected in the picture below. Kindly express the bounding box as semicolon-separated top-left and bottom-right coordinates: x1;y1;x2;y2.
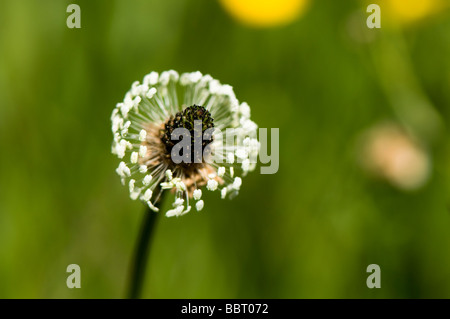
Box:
128;200;162;299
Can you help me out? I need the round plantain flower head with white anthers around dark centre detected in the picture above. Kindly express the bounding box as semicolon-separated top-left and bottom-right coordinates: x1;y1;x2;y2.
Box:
111;70;259;217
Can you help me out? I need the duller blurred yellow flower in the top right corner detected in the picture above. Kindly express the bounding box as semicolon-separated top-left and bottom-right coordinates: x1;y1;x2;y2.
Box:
381;0;448;24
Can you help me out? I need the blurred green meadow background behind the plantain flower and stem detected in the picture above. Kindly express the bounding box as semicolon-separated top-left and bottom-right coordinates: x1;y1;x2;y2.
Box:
0;0;450;298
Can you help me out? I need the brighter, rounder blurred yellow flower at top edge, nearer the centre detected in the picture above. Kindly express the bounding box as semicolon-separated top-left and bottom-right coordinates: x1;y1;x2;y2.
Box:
220;0;309;27
